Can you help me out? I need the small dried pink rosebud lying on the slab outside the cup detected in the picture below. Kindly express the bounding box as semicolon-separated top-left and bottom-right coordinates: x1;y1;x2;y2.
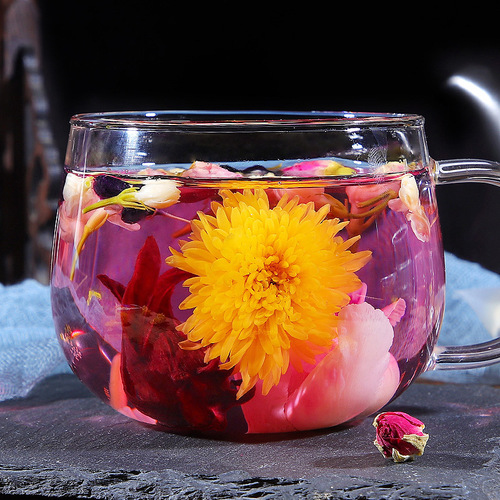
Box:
373;411;429;462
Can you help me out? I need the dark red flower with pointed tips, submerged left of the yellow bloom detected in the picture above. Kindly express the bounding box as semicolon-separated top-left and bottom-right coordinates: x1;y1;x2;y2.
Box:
99;236;254;432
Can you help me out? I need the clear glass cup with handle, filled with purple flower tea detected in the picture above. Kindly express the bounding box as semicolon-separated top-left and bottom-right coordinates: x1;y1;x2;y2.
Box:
51;112;500;434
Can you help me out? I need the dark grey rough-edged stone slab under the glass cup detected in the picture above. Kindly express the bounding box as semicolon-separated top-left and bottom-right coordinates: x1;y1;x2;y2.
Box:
0;375;500;500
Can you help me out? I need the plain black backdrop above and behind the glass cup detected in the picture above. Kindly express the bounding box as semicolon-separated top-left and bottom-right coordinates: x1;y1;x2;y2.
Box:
38;0;500;272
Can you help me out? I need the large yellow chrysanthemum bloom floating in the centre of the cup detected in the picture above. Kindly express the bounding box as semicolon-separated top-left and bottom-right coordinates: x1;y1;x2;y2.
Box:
167;189;371;397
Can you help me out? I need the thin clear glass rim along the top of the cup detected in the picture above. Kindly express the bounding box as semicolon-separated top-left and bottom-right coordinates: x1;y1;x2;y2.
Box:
70;110;424;131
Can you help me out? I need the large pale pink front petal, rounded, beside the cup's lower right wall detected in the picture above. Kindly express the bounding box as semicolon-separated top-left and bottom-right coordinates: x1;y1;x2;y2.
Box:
286;302;399;430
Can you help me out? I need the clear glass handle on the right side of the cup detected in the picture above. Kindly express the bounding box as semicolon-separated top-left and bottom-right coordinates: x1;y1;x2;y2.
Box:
428;159;500;370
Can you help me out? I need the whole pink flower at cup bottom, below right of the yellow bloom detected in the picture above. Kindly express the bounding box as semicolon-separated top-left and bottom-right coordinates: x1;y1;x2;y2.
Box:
242;302;400;432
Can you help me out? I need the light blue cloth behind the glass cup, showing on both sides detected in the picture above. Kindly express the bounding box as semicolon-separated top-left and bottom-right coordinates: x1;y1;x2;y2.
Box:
0;253;500;401
